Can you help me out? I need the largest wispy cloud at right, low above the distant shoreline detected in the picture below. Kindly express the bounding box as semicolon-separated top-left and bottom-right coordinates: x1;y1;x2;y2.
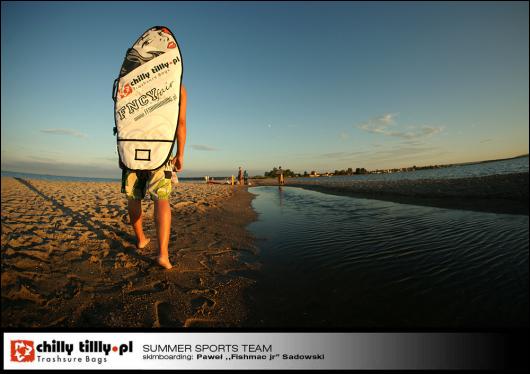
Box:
357;113;443;140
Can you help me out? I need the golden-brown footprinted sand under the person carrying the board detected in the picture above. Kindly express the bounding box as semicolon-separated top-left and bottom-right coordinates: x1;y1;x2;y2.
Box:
1;177;259;328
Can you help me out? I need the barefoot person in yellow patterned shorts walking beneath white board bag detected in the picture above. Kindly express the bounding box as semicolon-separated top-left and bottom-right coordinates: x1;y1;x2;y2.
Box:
122;85;186;269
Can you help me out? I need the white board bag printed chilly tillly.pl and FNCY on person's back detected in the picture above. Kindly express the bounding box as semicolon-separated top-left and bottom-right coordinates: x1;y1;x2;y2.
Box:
112;26;182;170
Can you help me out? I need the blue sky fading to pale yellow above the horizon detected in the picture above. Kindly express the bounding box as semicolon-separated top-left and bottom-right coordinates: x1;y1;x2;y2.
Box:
1;1;529;178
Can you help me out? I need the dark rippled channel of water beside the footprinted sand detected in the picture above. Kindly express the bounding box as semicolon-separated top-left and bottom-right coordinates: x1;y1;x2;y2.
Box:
245;187;528;328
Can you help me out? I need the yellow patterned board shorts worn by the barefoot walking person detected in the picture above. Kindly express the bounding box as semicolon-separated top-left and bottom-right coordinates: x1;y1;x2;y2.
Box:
121;158;173;200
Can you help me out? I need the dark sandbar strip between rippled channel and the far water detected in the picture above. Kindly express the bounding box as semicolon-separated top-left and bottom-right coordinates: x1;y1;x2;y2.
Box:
251;173;528;215
